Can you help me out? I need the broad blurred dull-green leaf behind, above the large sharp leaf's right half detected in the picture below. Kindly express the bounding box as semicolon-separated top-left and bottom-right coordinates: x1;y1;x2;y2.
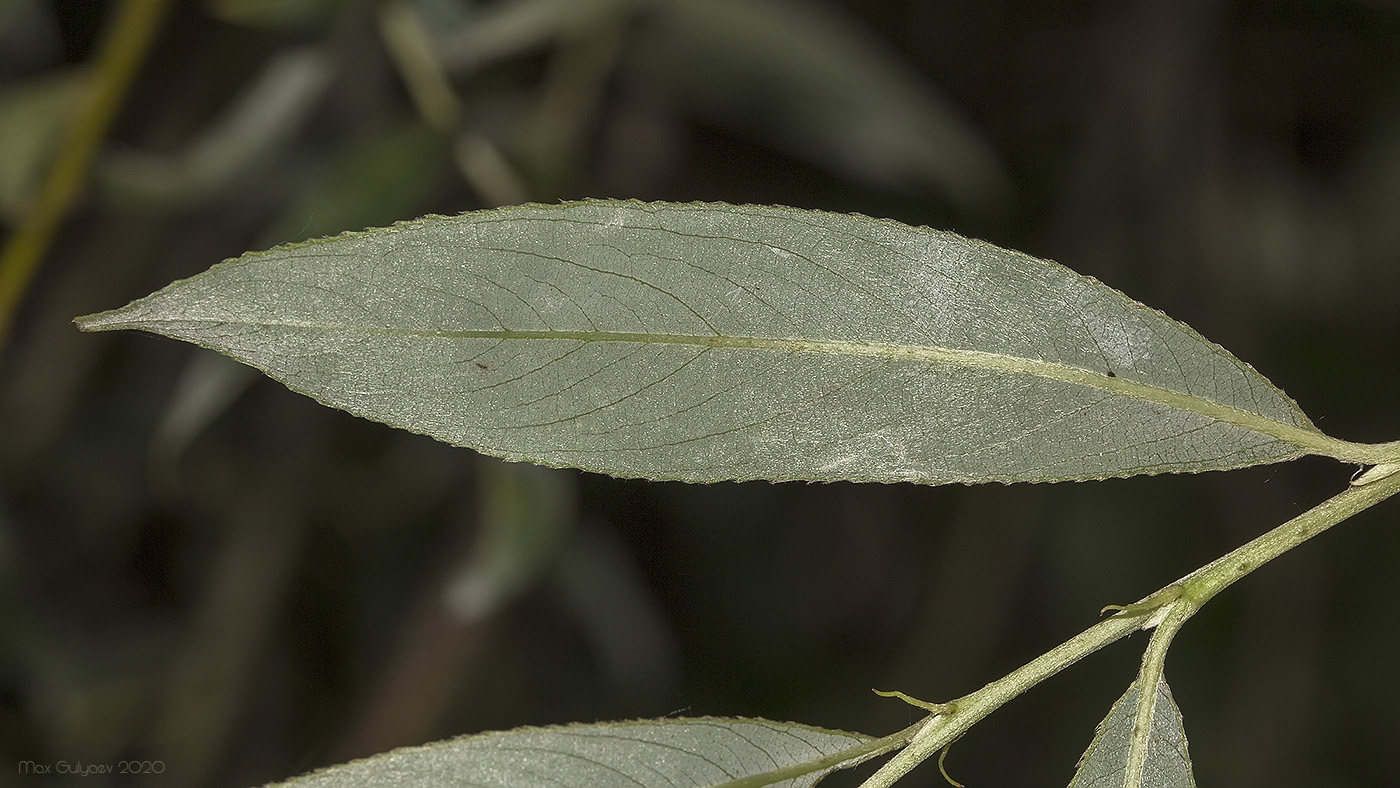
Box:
631;0;1007;210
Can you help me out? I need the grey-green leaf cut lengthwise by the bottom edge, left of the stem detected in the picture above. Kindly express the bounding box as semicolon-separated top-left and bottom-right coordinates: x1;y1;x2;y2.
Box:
263;718;875;788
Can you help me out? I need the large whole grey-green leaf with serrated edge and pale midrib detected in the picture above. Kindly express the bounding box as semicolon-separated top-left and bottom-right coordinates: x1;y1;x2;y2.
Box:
80;200;1320;483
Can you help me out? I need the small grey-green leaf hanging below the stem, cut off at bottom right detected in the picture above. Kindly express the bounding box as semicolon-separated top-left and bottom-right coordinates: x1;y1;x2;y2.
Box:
1070;680;1196;788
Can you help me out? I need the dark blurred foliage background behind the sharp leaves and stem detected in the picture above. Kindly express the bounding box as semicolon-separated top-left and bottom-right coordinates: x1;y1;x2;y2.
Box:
0;0;1400;788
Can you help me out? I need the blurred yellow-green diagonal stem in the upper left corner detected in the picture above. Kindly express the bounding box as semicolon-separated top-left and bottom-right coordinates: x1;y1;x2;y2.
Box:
0;0;169;349
